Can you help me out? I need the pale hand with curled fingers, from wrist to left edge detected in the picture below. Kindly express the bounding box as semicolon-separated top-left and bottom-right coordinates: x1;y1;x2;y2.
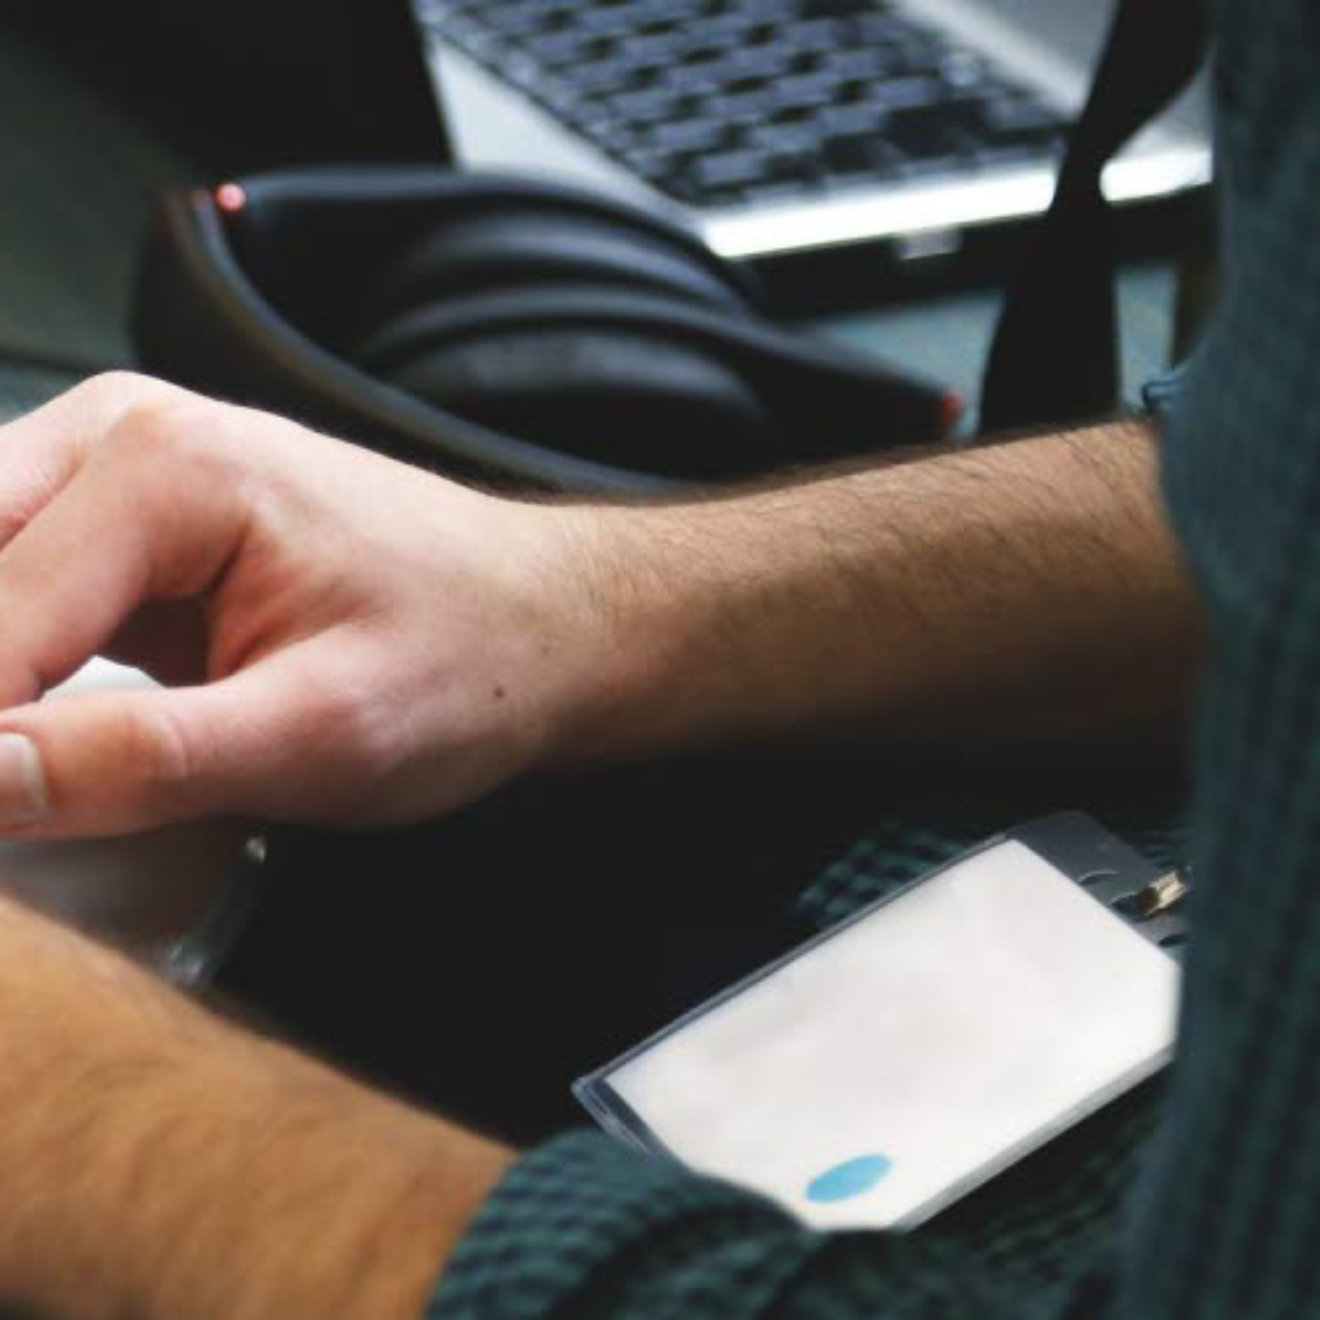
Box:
0;375;612;837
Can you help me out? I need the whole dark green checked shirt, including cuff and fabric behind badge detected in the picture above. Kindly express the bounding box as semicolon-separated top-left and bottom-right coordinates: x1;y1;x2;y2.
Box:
433;0;1320;1320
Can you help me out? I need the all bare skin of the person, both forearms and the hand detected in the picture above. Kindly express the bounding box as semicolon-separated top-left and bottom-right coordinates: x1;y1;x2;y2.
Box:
0;376;1197;1316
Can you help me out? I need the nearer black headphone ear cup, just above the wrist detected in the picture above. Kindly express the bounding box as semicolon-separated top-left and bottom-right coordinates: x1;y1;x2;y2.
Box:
358;270;950;479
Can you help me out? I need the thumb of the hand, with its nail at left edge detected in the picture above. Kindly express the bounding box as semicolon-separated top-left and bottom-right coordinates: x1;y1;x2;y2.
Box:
0;652;374;838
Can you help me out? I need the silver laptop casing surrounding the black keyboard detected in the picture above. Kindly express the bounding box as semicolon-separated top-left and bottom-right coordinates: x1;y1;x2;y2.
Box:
414;0;1210;259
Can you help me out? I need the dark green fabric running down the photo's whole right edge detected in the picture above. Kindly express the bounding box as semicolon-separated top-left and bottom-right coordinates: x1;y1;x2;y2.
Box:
1125;0;1320;1320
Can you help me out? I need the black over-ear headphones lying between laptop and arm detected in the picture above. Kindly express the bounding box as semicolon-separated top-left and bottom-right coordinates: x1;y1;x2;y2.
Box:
135;166;958;491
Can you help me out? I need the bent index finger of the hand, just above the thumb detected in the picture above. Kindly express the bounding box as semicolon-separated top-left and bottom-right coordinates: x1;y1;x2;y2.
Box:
0;413;246;708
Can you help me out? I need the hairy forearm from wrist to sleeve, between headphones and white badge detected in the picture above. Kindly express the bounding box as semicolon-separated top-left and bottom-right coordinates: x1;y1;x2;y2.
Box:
564;424;1197;758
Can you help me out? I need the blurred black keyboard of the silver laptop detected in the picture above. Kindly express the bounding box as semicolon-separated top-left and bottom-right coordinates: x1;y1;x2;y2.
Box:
417;0;1065;207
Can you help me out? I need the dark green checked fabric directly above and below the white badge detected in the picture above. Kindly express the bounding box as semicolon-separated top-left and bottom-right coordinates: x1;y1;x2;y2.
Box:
432;796;1181;1320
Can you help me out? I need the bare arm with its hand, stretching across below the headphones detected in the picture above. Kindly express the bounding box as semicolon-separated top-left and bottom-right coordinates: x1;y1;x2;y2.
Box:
0;378;1196;838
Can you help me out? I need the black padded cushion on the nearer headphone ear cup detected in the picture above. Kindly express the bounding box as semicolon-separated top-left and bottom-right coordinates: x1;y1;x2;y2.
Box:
383;327;780;480
